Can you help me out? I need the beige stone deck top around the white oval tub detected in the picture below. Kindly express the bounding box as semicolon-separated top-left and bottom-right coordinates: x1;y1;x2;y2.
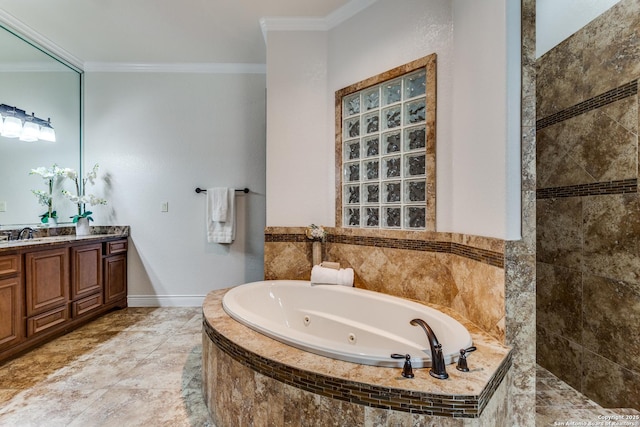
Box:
203;289;511;398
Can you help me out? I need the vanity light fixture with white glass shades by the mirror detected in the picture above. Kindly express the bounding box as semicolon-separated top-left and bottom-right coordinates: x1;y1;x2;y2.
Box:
0;104;56;142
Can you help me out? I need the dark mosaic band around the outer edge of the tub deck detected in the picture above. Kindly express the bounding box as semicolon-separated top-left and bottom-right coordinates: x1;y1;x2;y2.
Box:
202;313;512;418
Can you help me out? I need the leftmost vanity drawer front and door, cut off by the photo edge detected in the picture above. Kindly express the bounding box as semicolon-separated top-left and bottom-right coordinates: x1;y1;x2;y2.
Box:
0;254;24;351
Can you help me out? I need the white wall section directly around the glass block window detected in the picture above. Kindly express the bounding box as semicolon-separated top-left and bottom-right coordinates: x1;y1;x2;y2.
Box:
330;0;453;230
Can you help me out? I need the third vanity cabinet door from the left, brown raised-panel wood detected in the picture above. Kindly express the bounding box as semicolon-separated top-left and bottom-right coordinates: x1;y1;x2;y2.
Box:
71;243;102;300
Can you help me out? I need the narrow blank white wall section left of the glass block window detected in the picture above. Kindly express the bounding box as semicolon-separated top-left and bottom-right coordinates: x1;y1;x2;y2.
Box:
267;31;334;226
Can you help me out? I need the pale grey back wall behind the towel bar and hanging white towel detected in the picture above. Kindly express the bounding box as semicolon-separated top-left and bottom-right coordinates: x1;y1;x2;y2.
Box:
84;72;265;305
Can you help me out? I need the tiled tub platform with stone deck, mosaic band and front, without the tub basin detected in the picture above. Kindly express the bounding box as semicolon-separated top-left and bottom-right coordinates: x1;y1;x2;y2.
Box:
203;289;511;426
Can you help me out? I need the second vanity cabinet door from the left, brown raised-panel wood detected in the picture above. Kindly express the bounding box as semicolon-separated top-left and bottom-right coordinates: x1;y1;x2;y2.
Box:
24;248;69;316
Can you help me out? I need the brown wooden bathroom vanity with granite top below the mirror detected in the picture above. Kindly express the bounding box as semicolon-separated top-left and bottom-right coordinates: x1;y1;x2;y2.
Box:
0;230;128;362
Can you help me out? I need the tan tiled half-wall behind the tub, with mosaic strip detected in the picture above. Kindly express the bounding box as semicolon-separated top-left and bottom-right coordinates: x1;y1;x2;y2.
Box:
265;227;505;341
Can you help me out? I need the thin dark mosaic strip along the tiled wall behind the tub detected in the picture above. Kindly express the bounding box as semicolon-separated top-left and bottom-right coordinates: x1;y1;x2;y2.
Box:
264;233;504;268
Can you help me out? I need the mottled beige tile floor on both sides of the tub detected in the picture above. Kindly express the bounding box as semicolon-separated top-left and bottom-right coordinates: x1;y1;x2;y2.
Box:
0;307;640;427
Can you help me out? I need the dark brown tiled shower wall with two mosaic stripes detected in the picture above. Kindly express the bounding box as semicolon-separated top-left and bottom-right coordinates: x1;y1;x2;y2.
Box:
536;0;640;409
